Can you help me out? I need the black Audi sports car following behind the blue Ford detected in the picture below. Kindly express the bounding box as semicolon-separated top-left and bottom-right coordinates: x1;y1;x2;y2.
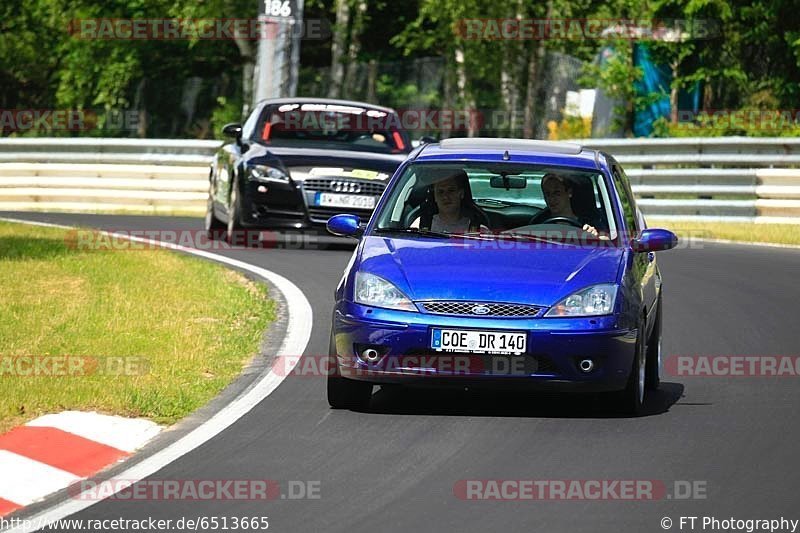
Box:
205;98;411;241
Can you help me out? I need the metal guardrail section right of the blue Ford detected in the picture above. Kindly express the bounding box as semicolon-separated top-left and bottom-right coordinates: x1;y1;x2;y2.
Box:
576;137;800;224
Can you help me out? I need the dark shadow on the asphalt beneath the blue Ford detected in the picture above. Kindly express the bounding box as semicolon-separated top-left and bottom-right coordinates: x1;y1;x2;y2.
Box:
360;382;683;418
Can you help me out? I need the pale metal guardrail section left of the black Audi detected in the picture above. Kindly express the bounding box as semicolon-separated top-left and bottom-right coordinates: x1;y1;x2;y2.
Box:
0;138;222;214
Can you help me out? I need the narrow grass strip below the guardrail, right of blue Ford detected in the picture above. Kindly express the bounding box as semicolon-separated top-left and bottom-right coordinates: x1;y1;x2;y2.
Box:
647;219;800;245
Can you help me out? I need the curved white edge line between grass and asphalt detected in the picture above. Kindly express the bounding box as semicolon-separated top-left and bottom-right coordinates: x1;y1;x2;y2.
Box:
0;217;314;533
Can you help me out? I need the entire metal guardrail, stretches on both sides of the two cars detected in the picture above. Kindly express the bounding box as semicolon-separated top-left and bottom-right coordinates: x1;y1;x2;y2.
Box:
0;137;800;223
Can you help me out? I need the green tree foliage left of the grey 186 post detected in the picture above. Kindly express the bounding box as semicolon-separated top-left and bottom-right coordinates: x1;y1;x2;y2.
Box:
0;0;244;137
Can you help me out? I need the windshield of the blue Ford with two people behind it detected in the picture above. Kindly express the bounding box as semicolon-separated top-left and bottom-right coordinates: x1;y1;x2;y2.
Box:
374;162;617;240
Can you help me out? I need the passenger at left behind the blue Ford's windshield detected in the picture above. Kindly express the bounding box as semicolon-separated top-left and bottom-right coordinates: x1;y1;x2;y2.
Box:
411;170;490;233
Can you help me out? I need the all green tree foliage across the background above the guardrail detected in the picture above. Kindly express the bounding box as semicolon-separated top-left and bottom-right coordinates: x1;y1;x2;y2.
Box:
0;0;800;137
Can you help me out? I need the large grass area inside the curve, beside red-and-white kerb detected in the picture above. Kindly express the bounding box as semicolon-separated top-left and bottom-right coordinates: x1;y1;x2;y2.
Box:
0;222;275;431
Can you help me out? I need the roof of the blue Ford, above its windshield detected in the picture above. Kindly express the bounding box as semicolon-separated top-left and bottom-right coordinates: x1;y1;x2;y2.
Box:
411;138;602;170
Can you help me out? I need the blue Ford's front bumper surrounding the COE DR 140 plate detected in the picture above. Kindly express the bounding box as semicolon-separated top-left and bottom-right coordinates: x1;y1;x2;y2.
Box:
333;301;637;392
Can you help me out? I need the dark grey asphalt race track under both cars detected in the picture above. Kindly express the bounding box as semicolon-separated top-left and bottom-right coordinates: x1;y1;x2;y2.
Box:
0;213;800;532
